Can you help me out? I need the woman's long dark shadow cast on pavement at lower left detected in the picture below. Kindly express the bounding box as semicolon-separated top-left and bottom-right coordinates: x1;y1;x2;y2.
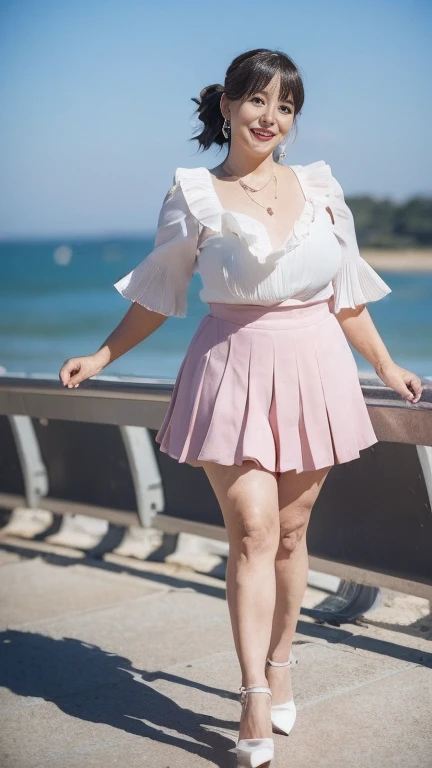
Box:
0;630;238;768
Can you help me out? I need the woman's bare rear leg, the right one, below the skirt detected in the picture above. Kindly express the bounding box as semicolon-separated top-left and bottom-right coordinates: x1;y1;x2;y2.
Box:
266;467;331;704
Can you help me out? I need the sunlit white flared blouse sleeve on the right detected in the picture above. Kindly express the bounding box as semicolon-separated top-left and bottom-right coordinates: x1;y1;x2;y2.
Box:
328;169;391;313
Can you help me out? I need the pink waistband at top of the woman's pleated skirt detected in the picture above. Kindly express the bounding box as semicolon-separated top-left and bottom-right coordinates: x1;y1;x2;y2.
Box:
209;301;331;330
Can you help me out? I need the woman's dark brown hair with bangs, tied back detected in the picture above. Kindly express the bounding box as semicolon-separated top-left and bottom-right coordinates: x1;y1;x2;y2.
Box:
189;48;304;151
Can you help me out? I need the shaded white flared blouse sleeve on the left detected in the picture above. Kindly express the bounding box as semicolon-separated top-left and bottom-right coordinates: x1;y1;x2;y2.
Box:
114;174;199;317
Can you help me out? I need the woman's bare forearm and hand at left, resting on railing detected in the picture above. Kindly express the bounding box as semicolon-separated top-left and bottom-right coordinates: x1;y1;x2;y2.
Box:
59;301;167;389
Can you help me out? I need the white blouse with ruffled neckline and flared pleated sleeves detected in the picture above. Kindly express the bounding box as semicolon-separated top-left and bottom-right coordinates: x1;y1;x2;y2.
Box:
115;160;391;317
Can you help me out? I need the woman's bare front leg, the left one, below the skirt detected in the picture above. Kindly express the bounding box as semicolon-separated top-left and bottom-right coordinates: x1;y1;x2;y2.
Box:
203;461;280;739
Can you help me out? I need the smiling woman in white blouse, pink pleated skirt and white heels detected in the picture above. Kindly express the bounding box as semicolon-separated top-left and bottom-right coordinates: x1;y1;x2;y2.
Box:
60;49;423;766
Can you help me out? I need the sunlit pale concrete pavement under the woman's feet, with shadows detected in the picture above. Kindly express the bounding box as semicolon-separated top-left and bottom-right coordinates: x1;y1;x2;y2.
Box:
0;516;432;768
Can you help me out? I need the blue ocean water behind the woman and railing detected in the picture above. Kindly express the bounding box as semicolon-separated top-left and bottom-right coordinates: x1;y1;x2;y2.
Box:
0;236;432;380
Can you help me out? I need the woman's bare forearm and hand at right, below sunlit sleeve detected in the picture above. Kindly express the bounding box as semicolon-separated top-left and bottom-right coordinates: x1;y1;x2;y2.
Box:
335;304;425;403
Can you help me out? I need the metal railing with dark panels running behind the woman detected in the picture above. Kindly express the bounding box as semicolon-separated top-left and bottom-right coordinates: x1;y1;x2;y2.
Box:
0;374;432;608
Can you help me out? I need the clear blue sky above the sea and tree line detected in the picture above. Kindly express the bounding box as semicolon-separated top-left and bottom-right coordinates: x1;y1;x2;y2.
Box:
0;0;432;239
